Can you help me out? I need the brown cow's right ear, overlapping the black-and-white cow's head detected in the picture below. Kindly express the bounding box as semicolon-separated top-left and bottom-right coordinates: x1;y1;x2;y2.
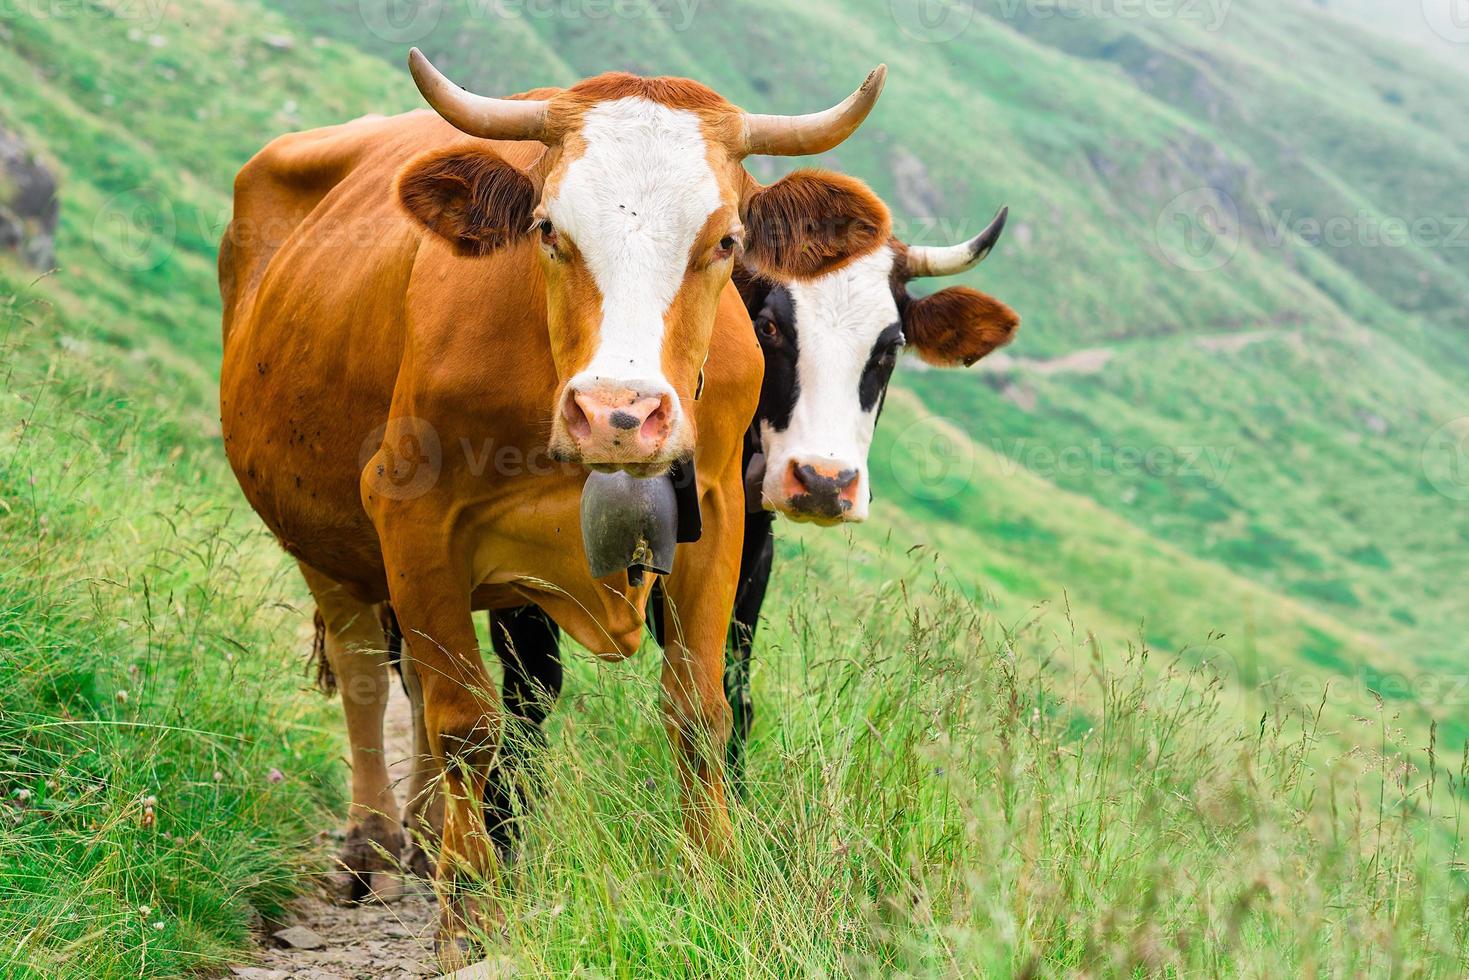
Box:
740;170;893;281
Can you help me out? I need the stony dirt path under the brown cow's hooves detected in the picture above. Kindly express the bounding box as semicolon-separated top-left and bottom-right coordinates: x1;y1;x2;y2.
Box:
229;685;439;980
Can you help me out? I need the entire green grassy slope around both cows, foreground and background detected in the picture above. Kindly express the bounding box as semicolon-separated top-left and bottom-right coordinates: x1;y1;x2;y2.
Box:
0;0;1469;977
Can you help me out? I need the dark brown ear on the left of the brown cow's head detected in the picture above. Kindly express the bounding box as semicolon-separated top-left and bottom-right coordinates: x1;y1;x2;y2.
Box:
398;148;536;256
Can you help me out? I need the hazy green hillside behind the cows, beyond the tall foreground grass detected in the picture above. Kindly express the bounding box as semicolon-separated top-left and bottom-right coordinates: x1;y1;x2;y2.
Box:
264;0;1469;743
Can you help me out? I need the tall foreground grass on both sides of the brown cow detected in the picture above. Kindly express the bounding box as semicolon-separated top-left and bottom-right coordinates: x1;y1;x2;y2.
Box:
0;279;1469;977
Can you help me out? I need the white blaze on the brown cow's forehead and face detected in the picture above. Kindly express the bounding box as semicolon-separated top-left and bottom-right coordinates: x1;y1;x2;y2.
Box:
546;97;723;386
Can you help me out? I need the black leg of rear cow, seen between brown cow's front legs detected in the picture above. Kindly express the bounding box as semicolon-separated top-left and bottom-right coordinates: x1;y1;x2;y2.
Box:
485;605;561;860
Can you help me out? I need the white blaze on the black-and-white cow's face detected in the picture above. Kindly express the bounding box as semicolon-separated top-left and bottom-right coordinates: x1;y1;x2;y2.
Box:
759;245;898;520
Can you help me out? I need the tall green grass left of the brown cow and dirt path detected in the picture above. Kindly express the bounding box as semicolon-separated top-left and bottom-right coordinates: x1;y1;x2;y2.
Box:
0;287;341;979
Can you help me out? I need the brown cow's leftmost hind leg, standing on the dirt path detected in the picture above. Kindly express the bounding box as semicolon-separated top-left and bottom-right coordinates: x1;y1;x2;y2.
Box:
301;564;403;902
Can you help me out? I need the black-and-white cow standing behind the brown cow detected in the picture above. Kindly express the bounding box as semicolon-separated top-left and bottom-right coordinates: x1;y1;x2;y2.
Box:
399;209;1019;848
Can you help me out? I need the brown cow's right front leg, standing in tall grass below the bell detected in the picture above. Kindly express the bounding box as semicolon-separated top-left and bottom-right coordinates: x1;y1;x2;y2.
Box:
663;492;743;855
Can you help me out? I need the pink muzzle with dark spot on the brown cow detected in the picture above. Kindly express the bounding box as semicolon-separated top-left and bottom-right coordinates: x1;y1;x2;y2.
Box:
551;379;692;476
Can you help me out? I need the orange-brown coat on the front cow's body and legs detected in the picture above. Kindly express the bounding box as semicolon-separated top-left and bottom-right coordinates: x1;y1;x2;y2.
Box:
220;113;762;937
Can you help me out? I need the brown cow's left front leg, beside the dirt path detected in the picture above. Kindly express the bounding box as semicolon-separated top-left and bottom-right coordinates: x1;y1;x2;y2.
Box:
382;549;501;949
